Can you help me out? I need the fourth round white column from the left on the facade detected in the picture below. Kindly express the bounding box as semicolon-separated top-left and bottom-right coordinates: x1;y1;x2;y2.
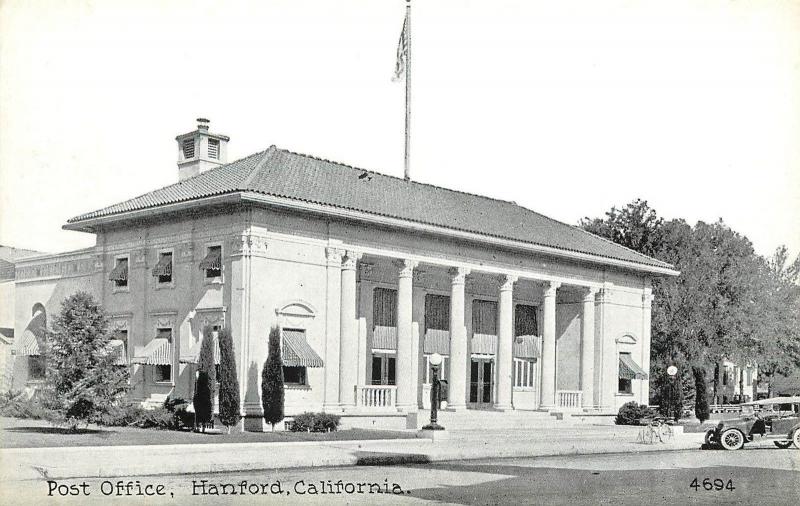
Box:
495;274;520;411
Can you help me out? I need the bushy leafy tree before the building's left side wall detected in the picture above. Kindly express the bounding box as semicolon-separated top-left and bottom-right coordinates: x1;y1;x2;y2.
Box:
41;292;129;430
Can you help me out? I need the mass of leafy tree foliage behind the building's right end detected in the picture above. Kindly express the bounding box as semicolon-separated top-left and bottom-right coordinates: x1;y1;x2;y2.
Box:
580;200;800;400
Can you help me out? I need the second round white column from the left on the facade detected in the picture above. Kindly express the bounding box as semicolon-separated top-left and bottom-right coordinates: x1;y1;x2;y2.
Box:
395;259;417;412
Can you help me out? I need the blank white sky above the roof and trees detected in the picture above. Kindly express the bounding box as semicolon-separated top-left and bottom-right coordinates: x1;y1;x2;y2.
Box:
0;0;800;255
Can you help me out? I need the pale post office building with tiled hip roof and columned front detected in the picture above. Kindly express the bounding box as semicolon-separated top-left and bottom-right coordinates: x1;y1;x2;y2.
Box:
10;120;678;428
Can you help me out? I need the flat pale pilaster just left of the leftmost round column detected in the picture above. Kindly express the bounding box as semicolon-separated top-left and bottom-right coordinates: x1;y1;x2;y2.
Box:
322;247;344;411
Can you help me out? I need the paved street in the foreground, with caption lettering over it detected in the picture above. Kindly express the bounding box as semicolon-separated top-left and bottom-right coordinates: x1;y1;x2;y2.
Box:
0;445;800;505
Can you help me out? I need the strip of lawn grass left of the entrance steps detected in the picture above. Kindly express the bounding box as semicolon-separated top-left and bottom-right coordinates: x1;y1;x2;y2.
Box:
0;417;415;448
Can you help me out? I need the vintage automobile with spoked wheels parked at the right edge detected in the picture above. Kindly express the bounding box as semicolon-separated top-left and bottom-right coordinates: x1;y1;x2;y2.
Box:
705;396;800;450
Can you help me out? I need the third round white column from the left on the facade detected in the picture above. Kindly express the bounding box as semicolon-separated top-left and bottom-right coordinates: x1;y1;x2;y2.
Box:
448;267;469;410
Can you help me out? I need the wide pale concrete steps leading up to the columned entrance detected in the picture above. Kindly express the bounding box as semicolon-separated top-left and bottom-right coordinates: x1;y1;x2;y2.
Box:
417;409;574;431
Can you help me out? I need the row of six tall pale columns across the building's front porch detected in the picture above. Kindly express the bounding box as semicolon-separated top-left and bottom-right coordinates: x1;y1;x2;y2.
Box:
324;247;597;412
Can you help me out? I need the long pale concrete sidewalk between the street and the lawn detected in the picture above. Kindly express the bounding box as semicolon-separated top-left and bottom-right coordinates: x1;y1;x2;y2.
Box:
0;426;703;481
